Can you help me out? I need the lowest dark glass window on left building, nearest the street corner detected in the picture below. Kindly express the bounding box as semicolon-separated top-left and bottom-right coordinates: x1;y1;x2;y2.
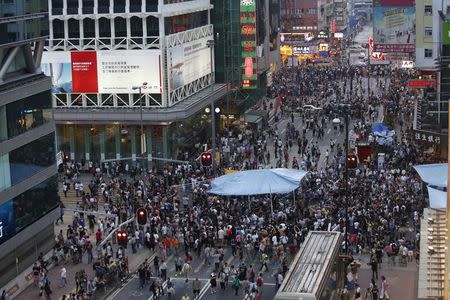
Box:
13;175;58;231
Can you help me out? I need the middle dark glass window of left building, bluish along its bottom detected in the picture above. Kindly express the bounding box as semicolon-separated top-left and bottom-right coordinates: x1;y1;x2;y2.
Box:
9;133;56;185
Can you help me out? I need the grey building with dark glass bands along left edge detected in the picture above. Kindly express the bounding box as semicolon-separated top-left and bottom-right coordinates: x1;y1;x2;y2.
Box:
0;0;58;288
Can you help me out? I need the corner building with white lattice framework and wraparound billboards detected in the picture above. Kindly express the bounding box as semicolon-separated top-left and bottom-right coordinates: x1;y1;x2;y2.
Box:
43;0;227;168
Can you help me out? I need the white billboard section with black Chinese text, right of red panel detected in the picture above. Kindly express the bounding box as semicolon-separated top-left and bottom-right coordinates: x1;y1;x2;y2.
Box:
97;50;161;94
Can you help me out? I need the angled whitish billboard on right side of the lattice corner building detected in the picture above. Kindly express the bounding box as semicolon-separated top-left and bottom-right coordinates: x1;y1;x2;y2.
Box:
167;36;214;91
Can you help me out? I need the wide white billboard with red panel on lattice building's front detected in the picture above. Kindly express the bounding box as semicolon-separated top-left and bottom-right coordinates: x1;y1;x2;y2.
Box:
41;50;161;94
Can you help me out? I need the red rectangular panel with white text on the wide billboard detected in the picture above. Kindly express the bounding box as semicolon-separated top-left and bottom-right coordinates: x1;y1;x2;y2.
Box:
70;51;98;93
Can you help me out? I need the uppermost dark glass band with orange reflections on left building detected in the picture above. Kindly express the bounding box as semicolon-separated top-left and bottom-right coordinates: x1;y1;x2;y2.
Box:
0;91;53;141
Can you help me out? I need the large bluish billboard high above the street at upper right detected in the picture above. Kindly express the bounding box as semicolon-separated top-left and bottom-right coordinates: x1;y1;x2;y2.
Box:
373;0;416;52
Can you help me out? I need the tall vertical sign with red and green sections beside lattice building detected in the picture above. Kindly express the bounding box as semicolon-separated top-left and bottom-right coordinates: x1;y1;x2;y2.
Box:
240;0;258;89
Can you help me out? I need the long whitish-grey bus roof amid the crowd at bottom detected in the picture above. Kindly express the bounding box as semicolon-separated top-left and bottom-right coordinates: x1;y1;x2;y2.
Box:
275;231;345;300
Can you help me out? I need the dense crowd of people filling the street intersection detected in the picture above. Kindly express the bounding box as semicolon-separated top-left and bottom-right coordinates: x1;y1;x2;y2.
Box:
26;31;426;299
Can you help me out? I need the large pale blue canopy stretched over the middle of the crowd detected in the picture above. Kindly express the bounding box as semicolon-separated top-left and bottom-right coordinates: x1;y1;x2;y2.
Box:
209;168;307;196
